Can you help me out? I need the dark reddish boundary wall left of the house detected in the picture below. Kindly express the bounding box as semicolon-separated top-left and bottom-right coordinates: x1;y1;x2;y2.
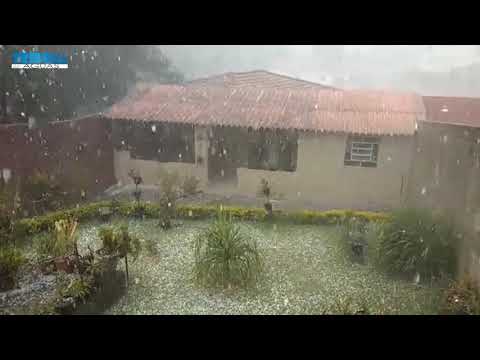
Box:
0;116;116;198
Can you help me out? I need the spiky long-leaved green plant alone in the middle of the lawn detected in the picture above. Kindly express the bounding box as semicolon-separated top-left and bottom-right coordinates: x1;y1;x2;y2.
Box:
194;213;263;288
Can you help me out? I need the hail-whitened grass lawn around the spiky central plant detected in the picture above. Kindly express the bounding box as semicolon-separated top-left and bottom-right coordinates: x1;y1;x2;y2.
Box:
79;220;438;314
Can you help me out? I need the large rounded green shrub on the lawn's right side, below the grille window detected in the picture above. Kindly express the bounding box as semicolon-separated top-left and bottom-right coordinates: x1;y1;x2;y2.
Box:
378;209;456;278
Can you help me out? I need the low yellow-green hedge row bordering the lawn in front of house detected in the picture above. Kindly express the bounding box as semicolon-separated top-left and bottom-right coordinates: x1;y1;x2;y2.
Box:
14;201;390;236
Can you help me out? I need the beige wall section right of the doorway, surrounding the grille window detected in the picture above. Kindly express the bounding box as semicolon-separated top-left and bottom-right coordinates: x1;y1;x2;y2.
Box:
238;133;413;209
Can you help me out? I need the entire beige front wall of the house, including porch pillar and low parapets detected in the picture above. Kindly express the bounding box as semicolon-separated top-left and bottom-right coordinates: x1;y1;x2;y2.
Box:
115;128;413;210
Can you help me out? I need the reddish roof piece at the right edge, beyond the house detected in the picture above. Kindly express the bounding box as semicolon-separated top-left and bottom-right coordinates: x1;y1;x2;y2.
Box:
423;96;480;127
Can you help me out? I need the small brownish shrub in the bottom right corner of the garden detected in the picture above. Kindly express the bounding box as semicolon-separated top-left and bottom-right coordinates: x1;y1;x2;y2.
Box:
440;275;480;315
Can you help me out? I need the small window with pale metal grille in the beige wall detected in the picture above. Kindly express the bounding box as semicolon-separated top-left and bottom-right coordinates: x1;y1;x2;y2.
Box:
344;136;380;167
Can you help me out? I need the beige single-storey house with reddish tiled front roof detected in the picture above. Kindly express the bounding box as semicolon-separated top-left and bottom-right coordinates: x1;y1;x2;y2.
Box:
106;71;425;210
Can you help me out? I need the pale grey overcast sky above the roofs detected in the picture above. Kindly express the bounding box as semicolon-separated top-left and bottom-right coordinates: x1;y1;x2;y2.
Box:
162;45;480;96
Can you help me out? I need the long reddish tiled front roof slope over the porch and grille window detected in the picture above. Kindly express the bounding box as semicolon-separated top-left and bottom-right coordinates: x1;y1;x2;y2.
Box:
105;85;424;135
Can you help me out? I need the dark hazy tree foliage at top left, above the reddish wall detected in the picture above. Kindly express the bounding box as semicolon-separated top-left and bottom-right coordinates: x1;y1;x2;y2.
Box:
0;45;183;123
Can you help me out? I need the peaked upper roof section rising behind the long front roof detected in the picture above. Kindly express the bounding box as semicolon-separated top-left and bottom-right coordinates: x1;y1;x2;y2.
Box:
187;70;333;89
